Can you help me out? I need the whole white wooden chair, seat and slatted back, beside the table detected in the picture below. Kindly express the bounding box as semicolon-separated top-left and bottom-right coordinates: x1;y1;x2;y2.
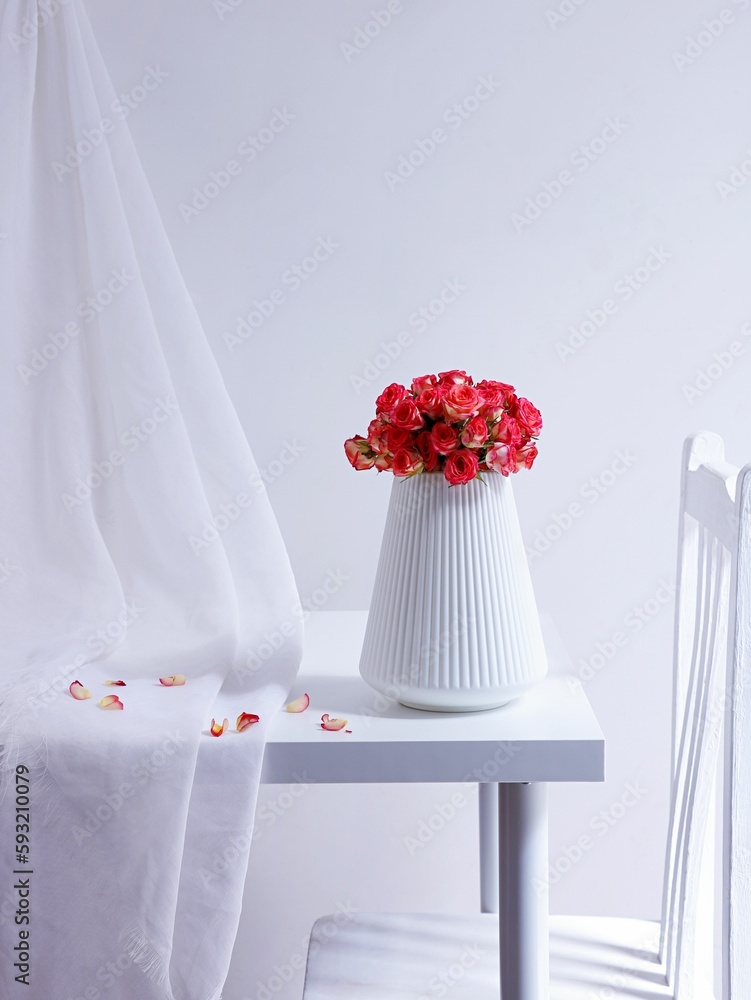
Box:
304;433;751;1000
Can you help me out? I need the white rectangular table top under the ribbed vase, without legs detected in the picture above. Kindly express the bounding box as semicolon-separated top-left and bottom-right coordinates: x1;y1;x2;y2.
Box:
262;611;605;784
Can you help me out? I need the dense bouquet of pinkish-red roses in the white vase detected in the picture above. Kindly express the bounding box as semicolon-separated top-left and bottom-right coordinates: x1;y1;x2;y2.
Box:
344;371;542;486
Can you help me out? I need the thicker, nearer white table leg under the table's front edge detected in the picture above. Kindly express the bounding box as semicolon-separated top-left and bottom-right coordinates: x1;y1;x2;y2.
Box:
498;782;550;1000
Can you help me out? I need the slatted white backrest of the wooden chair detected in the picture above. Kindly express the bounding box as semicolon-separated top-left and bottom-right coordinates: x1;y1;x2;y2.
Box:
661;433;751;1000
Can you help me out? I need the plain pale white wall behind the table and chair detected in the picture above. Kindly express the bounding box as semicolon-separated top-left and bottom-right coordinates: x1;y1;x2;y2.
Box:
85;0;751;1000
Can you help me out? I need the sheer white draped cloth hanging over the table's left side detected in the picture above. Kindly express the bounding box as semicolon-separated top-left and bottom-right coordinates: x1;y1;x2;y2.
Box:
0;0;301;1000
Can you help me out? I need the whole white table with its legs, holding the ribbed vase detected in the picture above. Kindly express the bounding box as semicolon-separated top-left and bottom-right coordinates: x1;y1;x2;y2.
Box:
262;612;605;1000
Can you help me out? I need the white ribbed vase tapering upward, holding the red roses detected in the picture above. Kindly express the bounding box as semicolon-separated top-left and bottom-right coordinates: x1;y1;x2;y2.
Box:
360;472;547;712
